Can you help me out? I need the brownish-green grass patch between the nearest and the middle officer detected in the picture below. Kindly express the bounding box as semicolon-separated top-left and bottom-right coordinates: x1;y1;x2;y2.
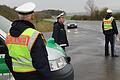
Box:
34;20;53;32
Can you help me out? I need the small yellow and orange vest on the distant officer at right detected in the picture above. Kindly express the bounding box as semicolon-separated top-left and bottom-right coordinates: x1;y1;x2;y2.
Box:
103;17;114;31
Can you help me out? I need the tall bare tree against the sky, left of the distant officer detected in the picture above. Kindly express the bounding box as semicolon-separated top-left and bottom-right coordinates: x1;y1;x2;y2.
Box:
85;0;98;18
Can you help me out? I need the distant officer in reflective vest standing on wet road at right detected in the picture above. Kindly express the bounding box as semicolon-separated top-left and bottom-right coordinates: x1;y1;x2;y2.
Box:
102;9;118;57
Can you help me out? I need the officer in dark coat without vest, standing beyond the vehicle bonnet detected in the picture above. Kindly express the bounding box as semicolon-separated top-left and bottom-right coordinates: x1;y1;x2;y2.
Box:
52;13;69;50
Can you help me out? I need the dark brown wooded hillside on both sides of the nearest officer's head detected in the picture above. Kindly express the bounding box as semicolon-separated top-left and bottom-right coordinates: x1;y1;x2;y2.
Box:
0;5;65;21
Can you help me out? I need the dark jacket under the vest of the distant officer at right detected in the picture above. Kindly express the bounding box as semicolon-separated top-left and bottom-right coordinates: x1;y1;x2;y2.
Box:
102;14;118;35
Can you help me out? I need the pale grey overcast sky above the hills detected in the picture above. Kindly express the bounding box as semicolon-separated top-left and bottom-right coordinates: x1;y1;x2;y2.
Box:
0;0;120;12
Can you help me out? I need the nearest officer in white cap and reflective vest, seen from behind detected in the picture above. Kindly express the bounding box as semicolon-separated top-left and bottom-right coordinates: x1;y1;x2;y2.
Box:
6;2;51;80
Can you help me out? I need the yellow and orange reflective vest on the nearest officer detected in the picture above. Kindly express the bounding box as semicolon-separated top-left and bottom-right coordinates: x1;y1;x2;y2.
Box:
6;28;45;72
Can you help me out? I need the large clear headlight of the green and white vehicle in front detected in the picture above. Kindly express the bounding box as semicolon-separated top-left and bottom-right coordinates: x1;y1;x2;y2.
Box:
49;57;67;71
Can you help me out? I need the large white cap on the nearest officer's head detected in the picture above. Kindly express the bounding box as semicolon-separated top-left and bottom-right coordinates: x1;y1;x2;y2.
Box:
15;2;36;14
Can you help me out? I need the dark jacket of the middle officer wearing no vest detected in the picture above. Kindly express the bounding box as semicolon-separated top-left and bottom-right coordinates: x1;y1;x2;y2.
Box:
52;22;69;46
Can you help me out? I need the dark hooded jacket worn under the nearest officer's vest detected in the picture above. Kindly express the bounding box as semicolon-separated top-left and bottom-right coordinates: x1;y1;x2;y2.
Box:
5;20;51;80
